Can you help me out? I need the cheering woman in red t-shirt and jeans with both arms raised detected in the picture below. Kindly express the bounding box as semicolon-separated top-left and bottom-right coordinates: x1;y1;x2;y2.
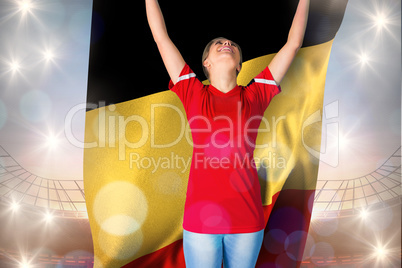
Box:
146;0;309;268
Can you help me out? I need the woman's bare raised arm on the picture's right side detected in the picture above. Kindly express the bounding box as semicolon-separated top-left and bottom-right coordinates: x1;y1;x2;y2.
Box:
268;0;310;85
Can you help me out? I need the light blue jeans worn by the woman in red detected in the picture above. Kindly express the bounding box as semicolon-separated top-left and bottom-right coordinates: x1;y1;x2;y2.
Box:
183;230;264;268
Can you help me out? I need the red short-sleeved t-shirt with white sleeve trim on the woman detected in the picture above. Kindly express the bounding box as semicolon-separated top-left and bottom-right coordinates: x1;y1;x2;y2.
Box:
169;64;281;234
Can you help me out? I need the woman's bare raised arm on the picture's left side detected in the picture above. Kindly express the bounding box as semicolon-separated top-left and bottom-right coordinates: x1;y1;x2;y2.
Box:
145;0;185;84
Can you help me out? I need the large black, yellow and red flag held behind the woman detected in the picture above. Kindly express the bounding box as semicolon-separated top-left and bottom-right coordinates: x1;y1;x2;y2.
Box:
84;0;347;268
